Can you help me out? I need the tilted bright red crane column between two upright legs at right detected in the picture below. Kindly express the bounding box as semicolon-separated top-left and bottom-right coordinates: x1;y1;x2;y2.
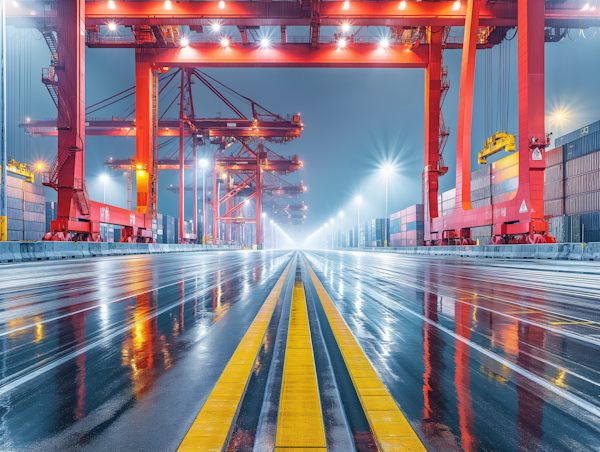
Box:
456;0;481;210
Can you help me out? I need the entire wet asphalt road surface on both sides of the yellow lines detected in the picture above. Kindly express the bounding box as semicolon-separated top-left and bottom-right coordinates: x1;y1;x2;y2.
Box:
0;251;600;452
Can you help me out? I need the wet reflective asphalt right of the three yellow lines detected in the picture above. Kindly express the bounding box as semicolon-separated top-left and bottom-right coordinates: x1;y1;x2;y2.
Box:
306;251;600;451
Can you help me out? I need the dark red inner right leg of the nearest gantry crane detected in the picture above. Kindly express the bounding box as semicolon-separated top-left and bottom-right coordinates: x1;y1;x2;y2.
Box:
423;27;444;221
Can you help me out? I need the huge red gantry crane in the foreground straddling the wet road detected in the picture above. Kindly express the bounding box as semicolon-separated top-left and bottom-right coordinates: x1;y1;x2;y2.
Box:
7;0;600;244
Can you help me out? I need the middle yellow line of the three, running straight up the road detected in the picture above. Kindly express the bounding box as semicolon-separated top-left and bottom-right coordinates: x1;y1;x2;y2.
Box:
275;266;327;452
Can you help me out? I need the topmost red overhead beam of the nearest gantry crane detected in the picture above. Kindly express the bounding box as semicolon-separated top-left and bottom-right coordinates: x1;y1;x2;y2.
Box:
6;0;600;28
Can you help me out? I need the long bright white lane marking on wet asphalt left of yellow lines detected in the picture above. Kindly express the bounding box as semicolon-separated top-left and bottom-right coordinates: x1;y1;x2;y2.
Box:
0;258;292;396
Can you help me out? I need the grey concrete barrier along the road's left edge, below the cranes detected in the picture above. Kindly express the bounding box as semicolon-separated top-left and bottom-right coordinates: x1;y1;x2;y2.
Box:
0;242;244;263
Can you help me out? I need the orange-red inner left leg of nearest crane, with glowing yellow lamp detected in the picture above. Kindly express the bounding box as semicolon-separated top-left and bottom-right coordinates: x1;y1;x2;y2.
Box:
135;49;154;224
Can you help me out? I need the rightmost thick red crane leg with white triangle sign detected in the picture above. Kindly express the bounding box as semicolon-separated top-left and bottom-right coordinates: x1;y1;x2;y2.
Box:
516;0;546;230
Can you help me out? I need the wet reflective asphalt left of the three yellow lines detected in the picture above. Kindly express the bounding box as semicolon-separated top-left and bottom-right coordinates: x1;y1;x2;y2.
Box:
0;251;291;452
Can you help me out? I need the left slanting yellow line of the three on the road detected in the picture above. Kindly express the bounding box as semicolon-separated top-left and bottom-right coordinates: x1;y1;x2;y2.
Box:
177;259;294;452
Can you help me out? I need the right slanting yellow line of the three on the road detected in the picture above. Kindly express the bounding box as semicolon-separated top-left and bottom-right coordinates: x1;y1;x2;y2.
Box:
304;259;426;452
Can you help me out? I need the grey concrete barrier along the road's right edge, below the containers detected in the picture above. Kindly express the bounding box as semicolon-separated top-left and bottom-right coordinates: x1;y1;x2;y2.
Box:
352;243;600;261
